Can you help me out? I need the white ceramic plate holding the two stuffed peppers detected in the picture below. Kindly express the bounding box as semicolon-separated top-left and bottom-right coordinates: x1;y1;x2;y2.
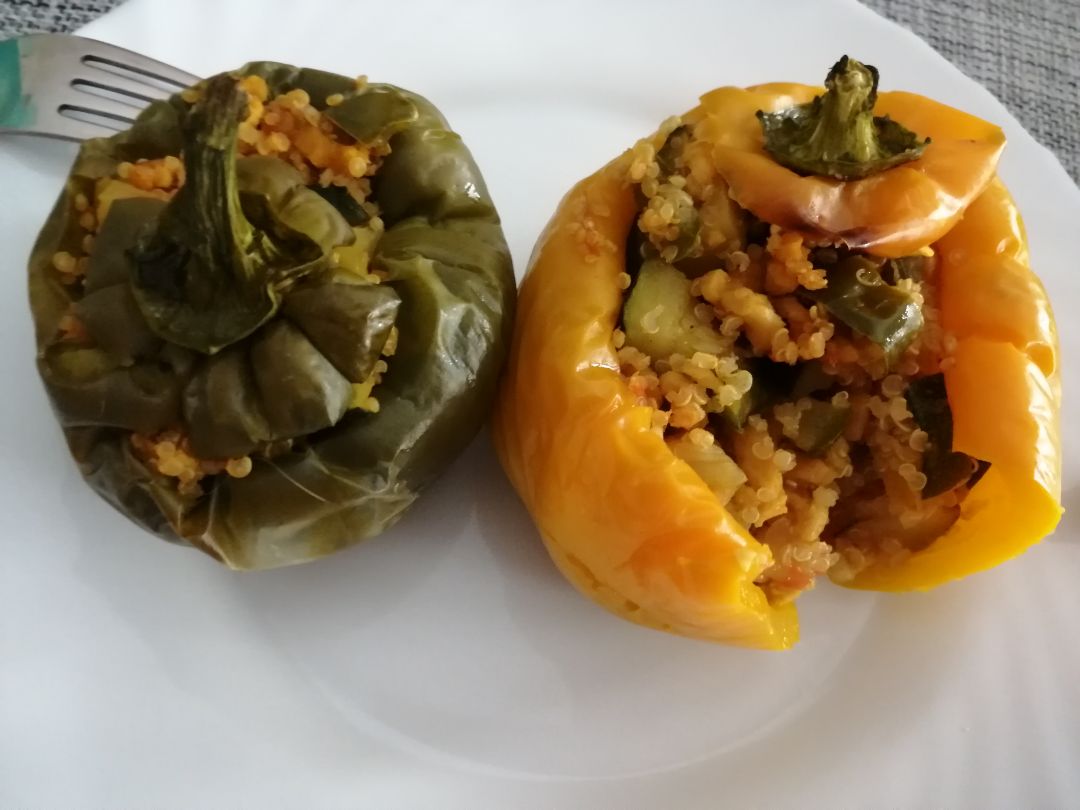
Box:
0;0;1080;809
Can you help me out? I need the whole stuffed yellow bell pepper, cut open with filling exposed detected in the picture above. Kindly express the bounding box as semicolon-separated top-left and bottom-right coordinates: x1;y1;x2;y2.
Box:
495;57;1062;649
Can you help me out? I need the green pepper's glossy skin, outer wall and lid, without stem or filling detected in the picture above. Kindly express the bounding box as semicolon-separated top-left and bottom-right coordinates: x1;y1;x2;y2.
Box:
29;63;515;569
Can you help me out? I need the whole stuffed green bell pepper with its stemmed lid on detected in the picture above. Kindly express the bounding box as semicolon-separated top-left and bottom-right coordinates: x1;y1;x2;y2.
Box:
29;63;514;569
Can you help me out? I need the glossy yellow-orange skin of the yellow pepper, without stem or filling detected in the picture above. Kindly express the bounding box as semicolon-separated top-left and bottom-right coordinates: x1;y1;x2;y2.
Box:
495;85;1061;649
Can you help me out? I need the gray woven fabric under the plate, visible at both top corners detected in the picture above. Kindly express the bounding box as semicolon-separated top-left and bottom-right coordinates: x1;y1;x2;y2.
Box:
0;0;1080;180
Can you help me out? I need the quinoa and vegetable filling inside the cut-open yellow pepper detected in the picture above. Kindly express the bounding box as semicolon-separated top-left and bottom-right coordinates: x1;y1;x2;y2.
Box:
613;118;986;604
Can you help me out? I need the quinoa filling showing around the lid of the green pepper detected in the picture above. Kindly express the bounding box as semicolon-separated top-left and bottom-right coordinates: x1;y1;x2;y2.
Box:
53;75;397;497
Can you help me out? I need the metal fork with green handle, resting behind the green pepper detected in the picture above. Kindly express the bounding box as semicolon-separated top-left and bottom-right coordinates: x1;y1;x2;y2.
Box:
0;33;199;140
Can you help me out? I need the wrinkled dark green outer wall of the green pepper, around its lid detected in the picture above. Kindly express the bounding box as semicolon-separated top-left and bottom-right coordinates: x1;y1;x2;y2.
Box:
29;63;515;569
